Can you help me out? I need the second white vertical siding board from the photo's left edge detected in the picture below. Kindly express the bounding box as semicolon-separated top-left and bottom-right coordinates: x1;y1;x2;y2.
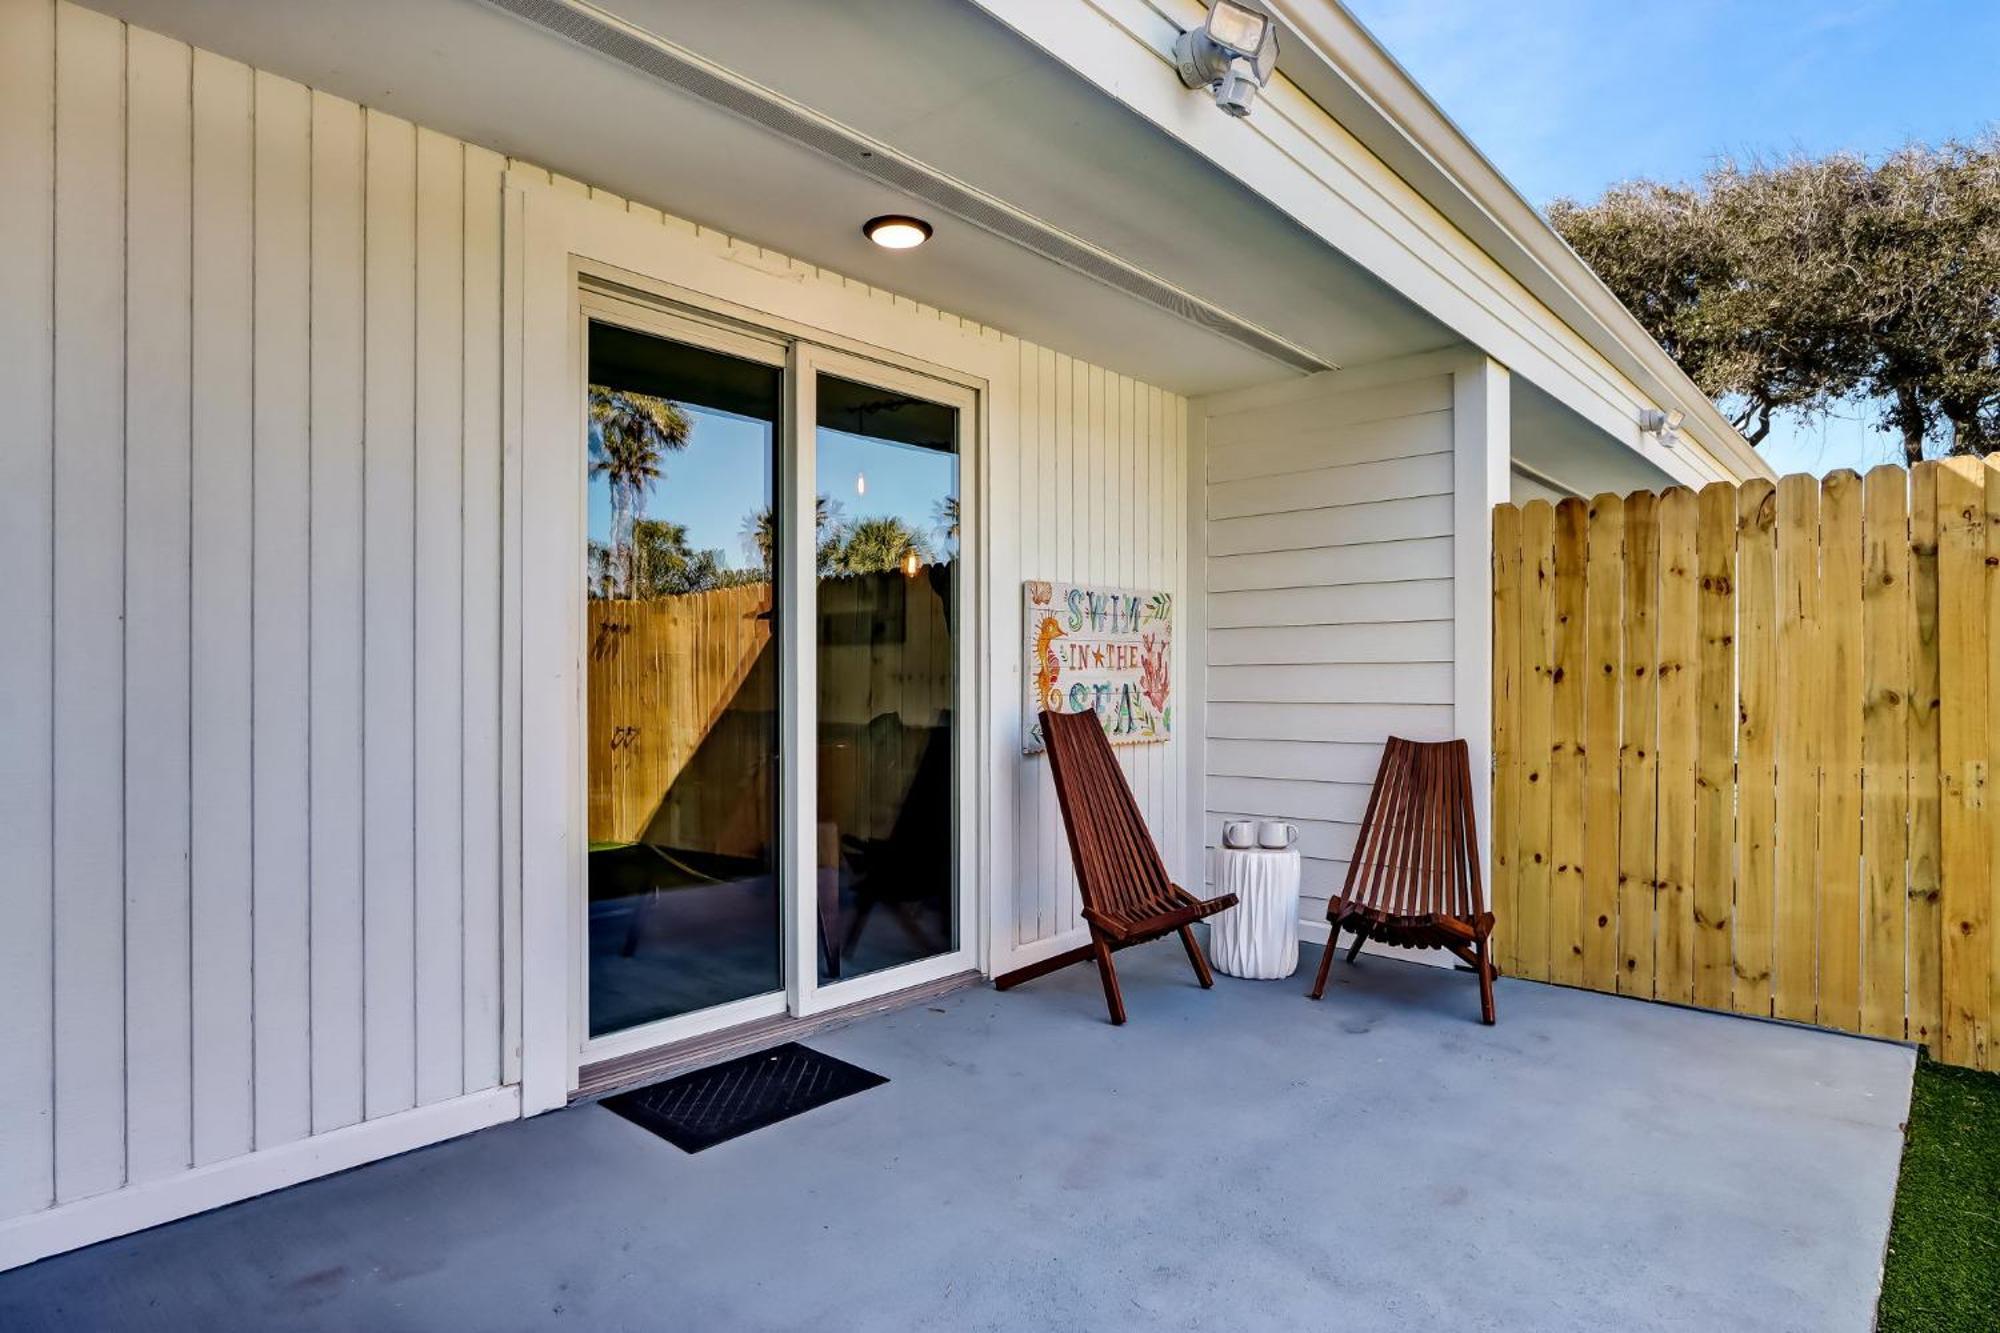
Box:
52;6;126;1203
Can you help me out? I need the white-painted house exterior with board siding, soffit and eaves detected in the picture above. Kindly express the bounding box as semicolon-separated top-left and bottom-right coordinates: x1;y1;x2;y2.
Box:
0;0;1764;1267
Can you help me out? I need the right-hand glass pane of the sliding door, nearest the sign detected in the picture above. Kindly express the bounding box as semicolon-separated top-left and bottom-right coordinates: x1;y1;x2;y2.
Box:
814;374;962;983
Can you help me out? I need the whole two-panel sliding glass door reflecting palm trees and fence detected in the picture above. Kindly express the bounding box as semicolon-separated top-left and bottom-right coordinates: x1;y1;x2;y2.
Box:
576;296;972;1059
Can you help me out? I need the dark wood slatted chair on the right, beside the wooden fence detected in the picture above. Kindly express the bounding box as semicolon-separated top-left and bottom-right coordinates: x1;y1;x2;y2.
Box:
1312;737;1500;1023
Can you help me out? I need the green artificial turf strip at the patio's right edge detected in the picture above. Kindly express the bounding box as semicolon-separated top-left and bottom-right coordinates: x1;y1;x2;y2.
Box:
1876;1061;2000;1333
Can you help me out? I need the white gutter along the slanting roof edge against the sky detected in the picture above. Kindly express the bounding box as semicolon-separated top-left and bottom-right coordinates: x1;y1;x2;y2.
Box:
1264;0;1776;476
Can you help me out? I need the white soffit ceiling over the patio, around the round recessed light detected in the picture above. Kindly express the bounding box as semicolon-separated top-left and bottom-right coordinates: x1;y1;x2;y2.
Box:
104;0;1454;394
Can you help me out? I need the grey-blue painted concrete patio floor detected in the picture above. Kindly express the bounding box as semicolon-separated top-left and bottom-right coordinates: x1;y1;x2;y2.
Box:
0;939;1914;1333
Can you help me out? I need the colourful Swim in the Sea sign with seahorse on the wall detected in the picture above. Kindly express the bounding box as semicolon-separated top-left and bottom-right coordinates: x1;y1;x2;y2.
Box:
1022;580;1174;755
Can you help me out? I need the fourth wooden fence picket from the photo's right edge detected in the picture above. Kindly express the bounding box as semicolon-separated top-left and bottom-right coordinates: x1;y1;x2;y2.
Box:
1860;464;1914;1039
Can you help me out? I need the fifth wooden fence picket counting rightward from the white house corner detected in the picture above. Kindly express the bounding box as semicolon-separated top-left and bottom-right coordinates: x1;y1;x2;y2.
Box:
1618;490;1660;984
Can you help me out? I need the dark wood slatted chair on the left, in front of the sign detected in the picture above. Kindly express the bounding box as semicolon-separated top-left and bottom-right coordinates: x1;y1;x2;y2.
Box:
994;713;1236;1023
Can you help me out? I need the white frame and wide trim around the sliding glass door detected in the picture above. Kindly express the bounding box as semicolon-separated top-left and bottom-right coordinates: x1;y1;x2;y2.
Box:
502;170;992;1115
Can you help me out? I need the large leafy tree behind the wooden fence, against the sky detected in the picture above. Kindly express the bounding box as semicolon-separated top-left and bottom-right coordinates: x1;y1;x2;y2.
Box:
1550;136;2000;462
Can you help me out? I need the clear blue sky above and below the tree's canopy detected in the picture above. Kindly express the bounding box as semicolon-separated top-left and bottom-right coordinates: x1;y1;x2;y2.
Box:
1344;0;2000;472
